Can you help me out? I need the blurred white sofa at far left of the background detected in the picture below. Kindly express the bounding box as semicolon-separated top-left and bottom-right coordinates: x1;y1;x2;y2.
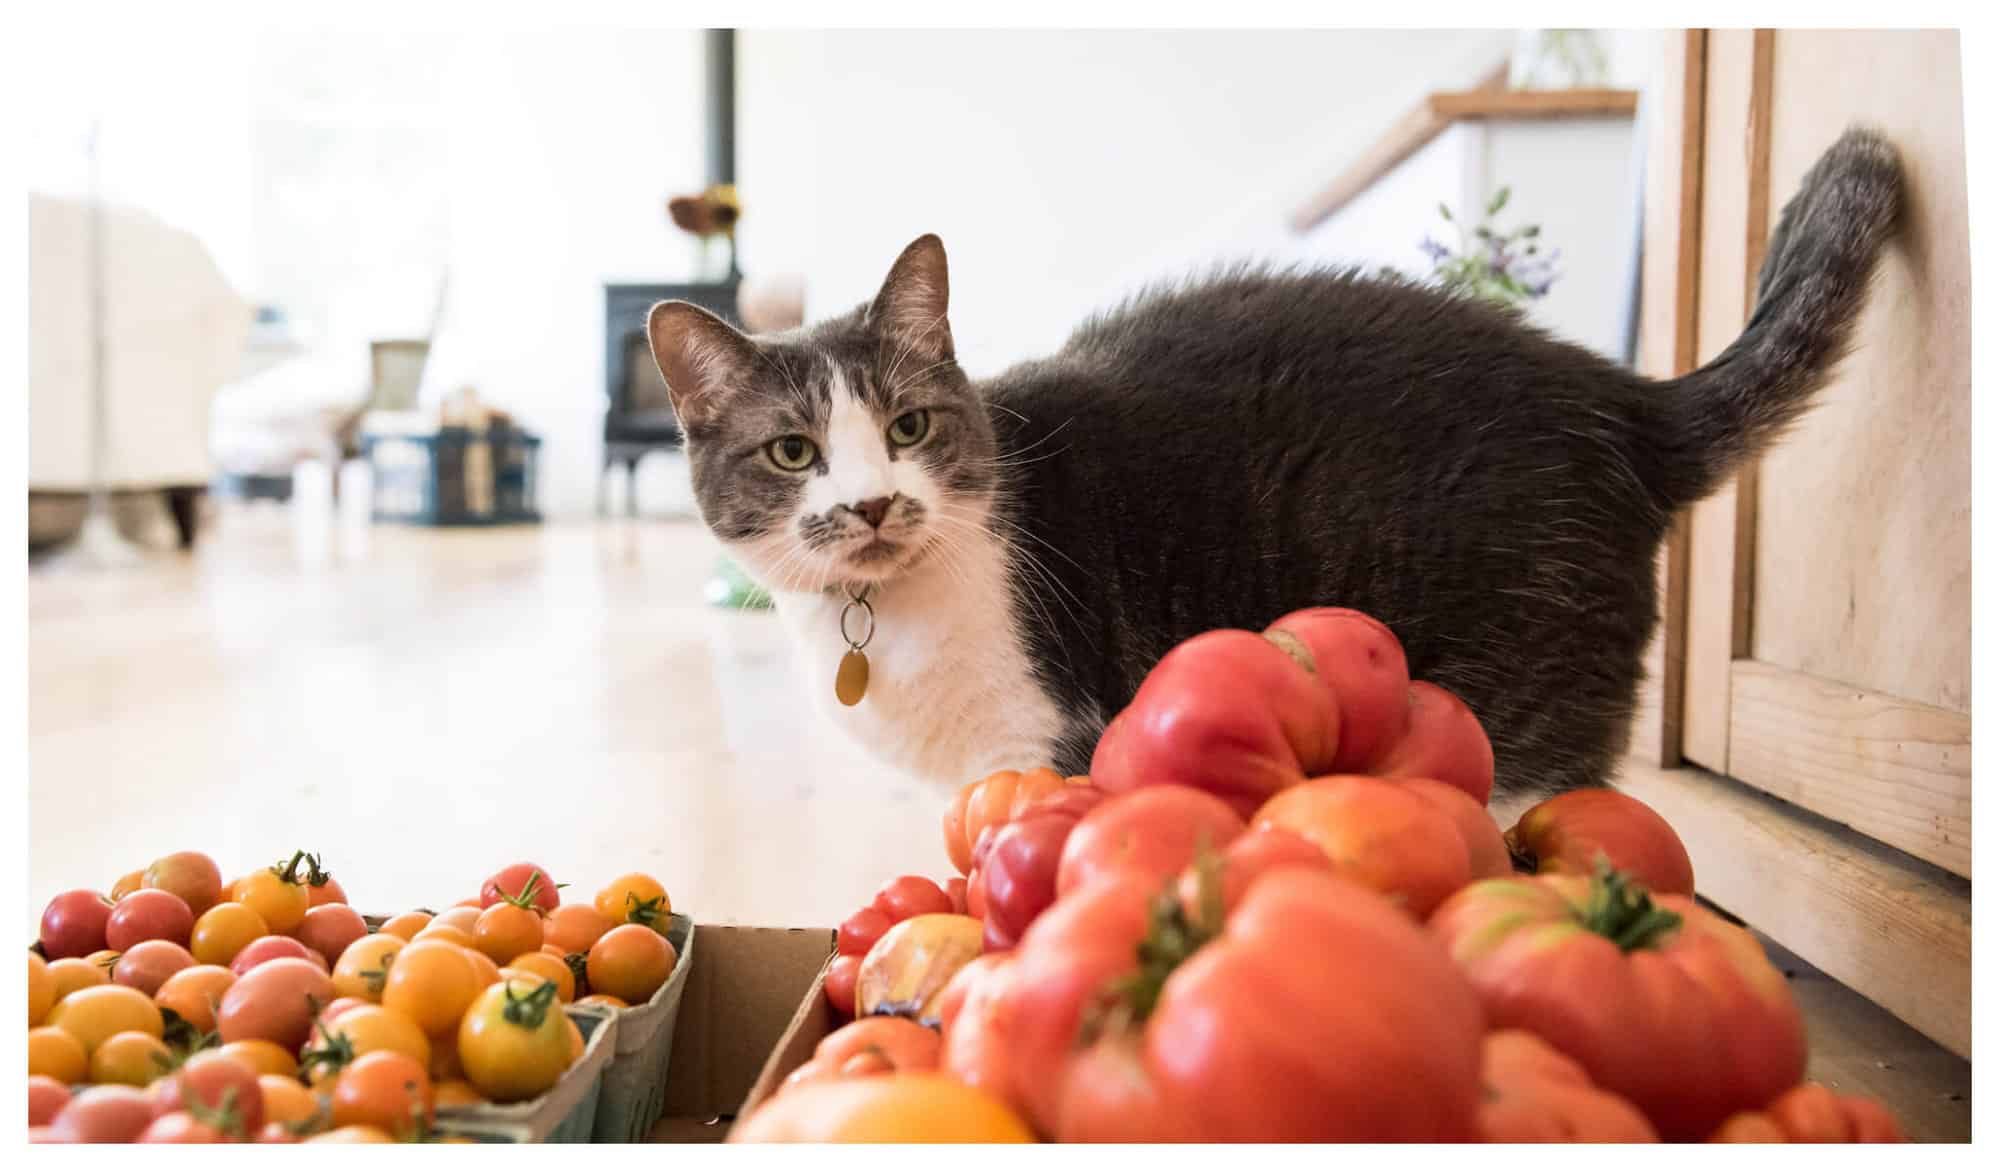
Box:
28;194;252;544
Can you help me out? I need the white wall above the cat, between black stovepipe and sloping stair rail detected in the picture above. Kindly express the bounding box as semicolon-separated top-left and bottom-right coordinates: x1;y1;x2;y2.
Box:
738;30;1514;374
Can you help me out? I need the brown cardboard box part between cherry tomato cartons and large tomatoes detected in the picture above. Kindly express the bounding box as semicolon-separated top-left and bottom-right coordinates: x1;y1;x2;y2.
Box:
650;924;834;1144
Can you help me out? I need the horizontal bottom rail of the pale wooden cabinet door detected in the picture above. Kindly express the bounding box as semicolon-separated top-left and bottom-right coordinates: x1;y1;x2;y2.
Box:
1730;660;1972;876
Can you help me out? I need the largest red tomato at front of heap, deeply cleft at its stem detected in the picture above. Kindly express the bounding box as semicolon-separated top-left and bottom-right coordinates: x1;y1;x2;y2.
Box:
944;864;1480;1142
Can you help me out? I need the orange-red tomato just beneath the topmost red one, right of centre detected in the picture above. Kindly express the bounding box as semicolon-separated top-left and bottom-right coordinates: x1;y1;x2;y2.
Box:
1254;776;1506;920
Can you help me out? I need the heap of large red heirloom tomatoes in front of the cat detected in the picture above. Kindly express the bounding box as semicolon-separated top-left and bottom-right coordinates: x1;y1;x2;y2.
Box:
732;608;1902;1142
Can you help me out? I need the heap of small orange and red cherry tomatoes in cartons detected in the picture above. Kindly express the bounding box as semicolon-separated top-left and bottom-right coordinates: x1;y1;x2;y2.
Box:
28;850;678;1142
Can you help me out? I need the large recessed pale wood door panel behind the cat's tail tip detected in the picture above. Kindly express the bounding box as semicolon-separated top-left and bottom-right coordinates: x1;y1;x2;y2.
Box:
1730;30;1972;712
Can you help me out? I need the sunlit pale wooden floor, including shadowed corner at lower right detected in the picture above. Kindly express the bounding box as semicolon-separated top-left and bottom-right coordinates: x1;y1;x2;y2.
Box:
24;506;1972;1140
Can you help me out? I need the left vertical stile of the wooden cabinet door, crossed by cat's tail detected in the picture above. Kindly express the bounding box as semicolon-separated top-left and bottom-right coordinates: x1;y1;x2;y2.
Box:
1680;28;1756;772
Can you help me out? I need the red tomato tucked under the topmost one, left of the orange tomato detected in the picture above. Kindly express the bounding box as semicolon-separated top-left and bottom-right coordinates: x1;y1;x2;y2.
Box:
1056;786;1244;896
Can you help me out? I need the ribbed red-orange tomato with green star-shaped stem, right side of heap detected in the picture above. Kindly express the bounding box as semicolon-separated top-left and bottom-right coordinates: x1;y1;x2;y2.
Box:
1430;870;1806;1140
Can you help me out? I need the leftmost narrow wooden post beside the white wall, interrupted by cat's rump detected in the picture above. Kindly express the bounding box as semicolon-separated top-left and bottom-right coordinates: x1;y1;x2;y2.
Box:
1630;28;1708;766
